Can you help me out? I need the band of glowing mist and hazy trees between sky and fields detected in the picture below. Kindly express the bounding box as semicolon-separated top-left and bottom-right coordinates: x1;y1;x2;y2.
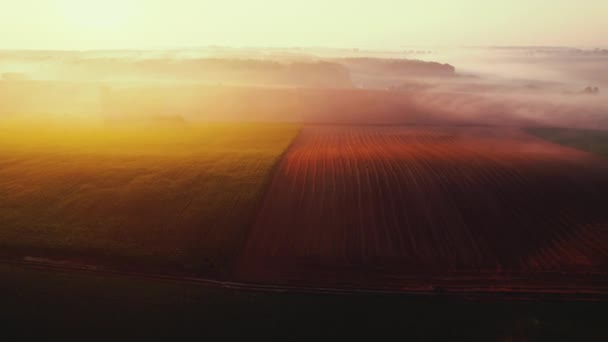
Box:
0;47;608;129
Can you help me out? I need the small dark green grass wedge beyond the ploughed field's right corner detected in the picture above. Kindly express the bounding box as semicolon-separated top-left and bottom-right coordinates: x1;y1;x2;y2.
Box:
528;128;608;157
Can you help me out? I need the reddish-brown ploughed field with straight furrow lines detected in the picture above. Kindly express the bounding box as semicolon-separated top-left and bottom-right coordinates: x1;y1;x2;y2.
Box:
237;126;608;288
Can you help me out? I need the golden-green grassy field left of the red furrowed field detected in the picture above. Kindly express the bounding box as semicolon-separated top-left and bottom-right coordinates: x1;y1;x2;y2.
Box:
0;121;299;272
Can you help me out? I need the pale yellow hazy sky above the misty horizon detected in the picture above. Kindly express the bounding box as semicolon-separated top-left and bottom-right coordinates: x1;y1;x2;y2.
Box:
0;0;608;49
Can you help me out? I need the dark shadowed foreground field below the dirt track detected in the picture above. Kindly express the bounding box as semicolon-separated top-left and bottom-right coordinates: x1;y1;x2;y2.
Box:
0;264;608;342
